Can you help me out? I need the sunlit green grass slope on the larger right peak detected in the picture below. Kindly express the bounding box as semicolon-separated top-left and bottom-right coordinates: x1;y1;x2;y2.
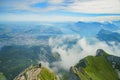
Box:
73;56;118;80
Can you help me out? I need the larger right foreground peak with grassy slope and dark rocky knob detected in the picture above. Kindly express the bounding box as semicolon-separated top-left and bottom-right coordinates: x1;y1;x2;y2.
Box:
71;49;120;80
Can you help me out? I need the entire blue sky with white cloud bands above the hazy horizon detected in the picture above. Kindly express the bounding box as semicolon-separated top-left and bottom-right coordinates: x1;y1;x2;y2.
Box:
0;0;120;22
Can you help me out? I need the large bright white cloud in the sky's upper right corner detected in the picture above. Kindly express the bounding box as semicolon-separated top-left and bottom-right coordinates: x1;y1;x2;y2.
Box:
65;0;120;14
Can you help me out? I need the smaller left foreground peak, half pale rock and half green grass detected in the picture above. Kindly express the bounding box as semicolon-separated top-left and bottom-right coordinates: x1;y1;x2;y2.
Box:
14;66;59;80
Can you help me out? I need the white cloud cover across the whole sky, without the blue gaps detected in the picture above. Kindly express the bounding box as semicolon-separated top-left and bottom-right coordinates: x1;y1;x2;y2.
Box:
0;0;120;22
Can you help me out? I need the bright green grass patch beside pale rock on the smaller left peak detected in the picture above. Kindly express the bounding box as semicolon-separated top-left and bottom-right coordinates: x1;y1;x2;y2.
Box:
38;68;58;80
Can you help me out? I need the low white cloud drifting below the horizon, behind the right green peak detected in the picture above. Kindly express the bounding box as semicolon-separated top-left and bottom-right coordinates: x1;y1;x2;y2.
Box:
49;35;120;70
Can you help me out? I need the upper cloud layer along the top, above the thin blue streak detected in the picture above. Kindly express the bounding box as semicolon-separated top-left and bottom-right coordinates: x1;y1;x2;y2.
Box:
0;0;120;14
